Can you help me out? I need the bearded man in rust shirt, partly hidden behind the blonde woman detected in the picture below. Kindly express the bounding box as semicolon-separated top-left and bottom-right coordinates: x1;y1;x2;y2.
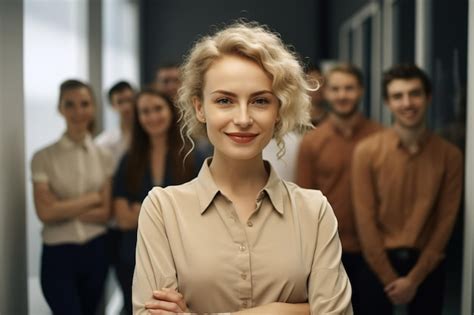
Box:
296;64;381;314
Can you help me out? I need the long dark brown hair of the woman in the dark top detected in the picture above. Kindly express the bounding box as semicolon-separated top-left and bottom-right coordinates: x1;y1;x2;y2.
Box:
125;88;195;194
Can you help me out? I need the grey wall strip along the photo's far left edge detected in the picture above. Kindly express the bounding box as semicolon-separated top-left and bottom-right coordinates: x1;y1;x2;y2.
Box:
0;1;27;315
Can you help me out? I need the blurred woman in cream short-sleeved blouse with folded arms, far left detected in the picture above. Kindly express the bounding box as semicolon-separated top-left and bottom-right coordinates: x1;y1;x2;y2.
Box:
31;80;113;315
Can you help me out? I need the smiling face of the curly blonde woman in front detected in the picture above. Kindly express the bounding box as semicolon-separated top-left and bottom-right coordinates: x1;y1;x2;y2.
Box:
193;55;279;160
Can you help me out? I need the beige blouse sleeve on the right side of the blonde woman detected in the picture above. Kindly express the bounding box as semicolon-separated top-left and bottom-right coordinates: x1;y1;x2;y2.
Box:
308;197;353;315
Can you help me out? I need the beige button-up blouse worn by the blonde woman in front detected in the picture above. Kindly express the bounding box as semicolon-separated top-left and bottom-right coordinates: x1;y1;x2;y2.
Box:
133;159;352;314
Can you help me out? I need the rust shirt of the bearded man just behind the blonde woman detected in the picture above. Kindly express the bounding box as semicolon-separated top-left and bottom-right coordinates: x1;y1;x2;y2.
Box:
296;114;381;252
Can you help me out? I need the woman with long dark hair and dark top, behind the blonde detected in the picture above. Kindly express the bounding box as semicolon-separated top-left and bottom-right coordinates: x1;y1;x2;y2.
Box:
113;89;202;314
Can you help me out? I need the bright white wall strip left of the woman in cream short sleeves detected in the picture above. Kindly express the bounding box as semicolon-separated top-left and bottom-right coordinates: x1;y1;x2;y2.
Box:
23;0;89;315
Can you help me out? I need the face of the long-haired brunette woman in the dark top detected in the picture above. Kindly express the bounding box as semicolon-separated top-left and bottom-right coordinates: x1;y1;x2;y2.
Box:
137;94;173;137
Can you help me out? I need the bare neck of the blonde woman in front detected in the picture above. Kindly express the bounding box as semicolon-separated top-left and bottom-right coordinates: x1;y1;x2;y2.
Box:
209;152;269;195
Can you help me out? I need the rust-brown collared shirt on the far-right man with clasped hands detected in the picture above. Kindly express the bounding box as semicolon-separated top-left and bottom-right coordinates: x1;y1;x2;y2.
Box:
352;128;463;284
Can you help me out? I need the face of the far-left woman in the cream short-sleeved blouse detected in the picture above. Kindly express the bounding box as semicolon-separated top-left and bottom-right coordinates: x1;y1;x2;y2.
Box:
59;88;95;132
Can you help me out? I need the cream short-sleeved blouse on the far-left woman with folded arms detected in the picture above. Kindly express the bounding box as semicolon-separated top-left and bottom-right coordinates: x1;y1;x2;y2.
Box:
31;135;114;245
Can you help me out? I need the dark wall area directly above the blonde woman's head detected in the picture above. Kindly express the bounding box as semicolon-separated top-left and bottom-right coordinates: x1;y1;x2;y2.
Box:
141;0;322;83
